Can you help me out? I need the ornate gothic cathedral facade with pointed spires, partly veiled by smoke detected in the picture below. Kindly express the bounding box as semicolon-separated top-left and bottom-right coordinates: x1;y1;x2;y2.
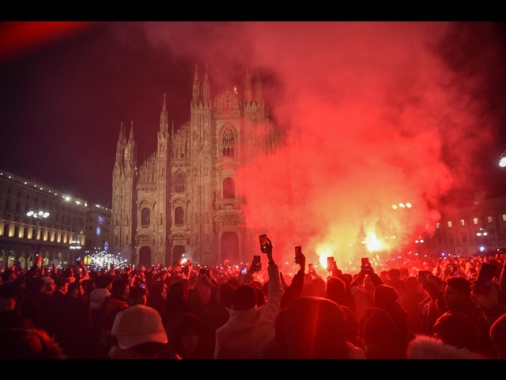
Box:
111;67;282;266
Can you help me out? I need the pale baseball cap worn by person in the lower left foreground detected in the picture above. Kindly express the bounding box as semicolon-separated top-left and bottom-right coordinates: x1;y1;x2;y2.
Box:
111;305;168;349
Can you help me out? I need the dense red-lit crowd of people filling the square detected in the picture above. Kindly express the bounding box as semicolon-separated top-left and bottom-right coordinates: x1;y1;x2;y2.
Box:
0;238;506;360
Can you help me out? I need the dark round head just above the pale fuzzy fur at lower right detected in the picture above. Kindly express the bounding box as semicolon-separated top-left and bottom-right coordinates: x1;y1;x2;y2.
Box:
434;313;478;351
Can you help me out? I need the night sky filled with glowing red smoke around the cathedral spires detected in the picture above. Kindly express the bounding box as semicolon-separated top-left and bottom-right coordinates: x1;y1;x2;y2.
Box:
0;21;506;264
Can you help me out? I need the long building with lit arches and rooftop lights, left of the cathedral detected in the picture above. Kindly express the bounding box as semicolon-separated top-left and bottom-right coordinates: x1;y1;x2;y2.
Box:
0;170;111;269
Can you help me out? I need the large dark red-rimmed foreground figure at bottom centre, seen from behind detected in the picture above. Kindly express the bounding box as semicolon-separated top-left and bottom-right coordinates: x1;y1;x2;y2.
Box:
262;296;366;359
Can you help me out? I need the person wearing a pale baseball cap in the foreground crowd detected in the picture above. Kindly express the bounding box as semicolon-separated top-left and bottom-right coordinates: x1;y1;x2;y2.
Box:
109;305;182;360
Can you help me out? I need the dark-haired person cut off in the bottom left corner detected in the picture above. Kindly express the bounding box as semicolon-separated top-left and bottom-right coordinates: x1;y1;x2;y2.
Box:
0;327;67;360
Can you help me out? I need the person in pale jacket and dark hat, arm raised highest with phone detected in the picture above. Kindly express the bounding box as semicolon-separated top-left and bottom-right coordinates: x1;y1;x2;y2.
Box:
214;238;283;359
